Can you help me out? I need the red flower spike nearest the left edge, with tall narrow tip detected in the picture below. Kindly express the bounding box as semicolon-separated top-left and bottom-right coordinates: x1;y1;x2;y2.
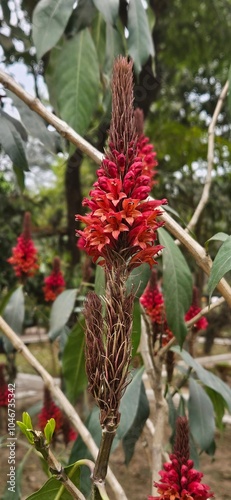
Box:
8;212;39;281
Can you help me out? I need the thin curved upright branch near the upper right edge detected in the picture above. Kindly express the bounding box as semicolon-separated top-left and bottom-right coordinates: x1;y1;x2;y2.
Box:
186;81;229;231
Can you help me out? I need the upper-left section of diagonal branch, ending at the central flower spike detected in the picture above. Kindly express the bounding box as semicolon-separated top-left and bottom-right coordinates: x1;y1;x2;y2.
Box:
0;69;103;163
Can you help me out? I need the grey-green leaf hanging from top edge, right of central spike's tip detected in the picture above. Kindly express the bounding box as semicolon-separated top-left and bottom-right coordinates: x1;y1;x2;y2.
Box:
127;0;154;74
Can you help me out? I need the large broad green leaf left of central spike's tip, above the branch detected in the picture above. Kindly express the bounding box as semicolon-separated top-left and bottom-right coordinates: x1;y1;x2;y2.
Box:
46;28;100;135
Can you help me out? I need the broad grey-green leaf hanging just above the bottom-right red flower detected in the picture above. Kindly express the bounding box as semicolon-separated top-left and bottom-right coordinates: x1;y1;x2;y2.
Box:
188;377;215;451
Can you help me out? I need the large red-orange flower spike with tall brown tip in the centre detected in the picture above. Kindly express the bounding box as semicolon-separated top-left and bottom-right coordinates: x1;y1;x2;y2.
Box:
76;58;166;271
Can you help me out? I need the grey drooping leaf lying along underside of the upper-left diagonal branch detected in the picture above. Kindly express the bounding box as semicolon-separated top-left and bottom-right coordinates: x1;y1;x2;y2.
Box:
7;90;57;152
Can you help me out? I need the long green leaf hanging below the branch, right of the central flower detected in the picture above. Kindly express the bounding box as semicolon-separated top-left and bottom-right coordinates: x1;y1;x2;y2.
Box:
158;228;193;346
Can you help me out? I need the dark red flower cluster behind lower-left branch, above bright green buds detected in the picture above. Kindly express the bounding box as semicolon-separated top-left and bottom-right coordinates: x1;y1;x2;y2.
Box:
38;388;77;445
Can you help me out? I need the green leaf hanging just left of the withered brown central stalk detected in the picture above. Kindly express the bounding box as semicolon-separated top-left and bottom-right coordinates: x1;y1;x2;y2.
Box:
62;323;87;403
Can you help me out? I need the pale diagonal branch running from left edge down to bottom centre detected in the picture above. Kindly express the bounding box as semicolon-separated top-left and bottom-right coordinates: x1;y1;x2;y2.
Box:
0;316;127;500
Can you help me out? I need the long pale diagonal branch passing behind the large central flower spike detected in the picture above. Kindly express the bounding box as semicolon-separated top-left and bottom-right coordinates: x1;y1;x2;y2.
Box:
0;70;231;307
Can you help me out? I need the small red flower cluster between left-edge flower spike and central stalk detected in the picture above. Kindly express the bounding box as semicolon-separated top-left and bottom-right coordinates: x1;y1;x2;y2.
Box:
43;257;66;302
